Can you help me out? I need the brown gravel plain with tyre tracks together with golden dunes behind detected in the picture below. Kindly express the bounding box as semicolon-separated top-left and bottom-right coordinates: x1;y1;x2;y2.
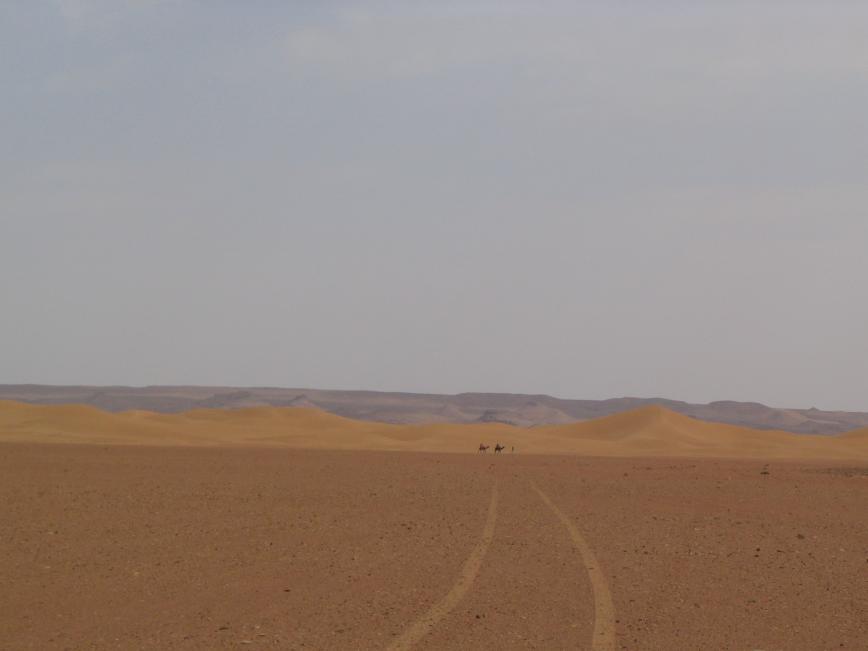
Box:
0;402;868;651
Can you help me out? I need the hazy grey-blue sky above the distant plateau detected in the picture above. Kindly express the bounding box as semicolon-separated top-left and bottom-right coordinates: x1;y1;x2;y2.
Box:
0;0;868;410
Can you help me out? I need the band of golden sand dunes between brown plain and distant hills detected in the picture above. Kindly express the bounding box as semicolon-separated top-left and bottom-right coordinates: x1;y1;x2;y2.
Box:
0;401;868;460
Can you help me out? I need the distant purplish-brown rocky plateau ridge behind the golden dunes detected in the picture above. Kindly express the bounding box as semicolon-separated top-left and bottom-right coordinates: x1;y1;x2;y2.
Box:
0;384;868;434
